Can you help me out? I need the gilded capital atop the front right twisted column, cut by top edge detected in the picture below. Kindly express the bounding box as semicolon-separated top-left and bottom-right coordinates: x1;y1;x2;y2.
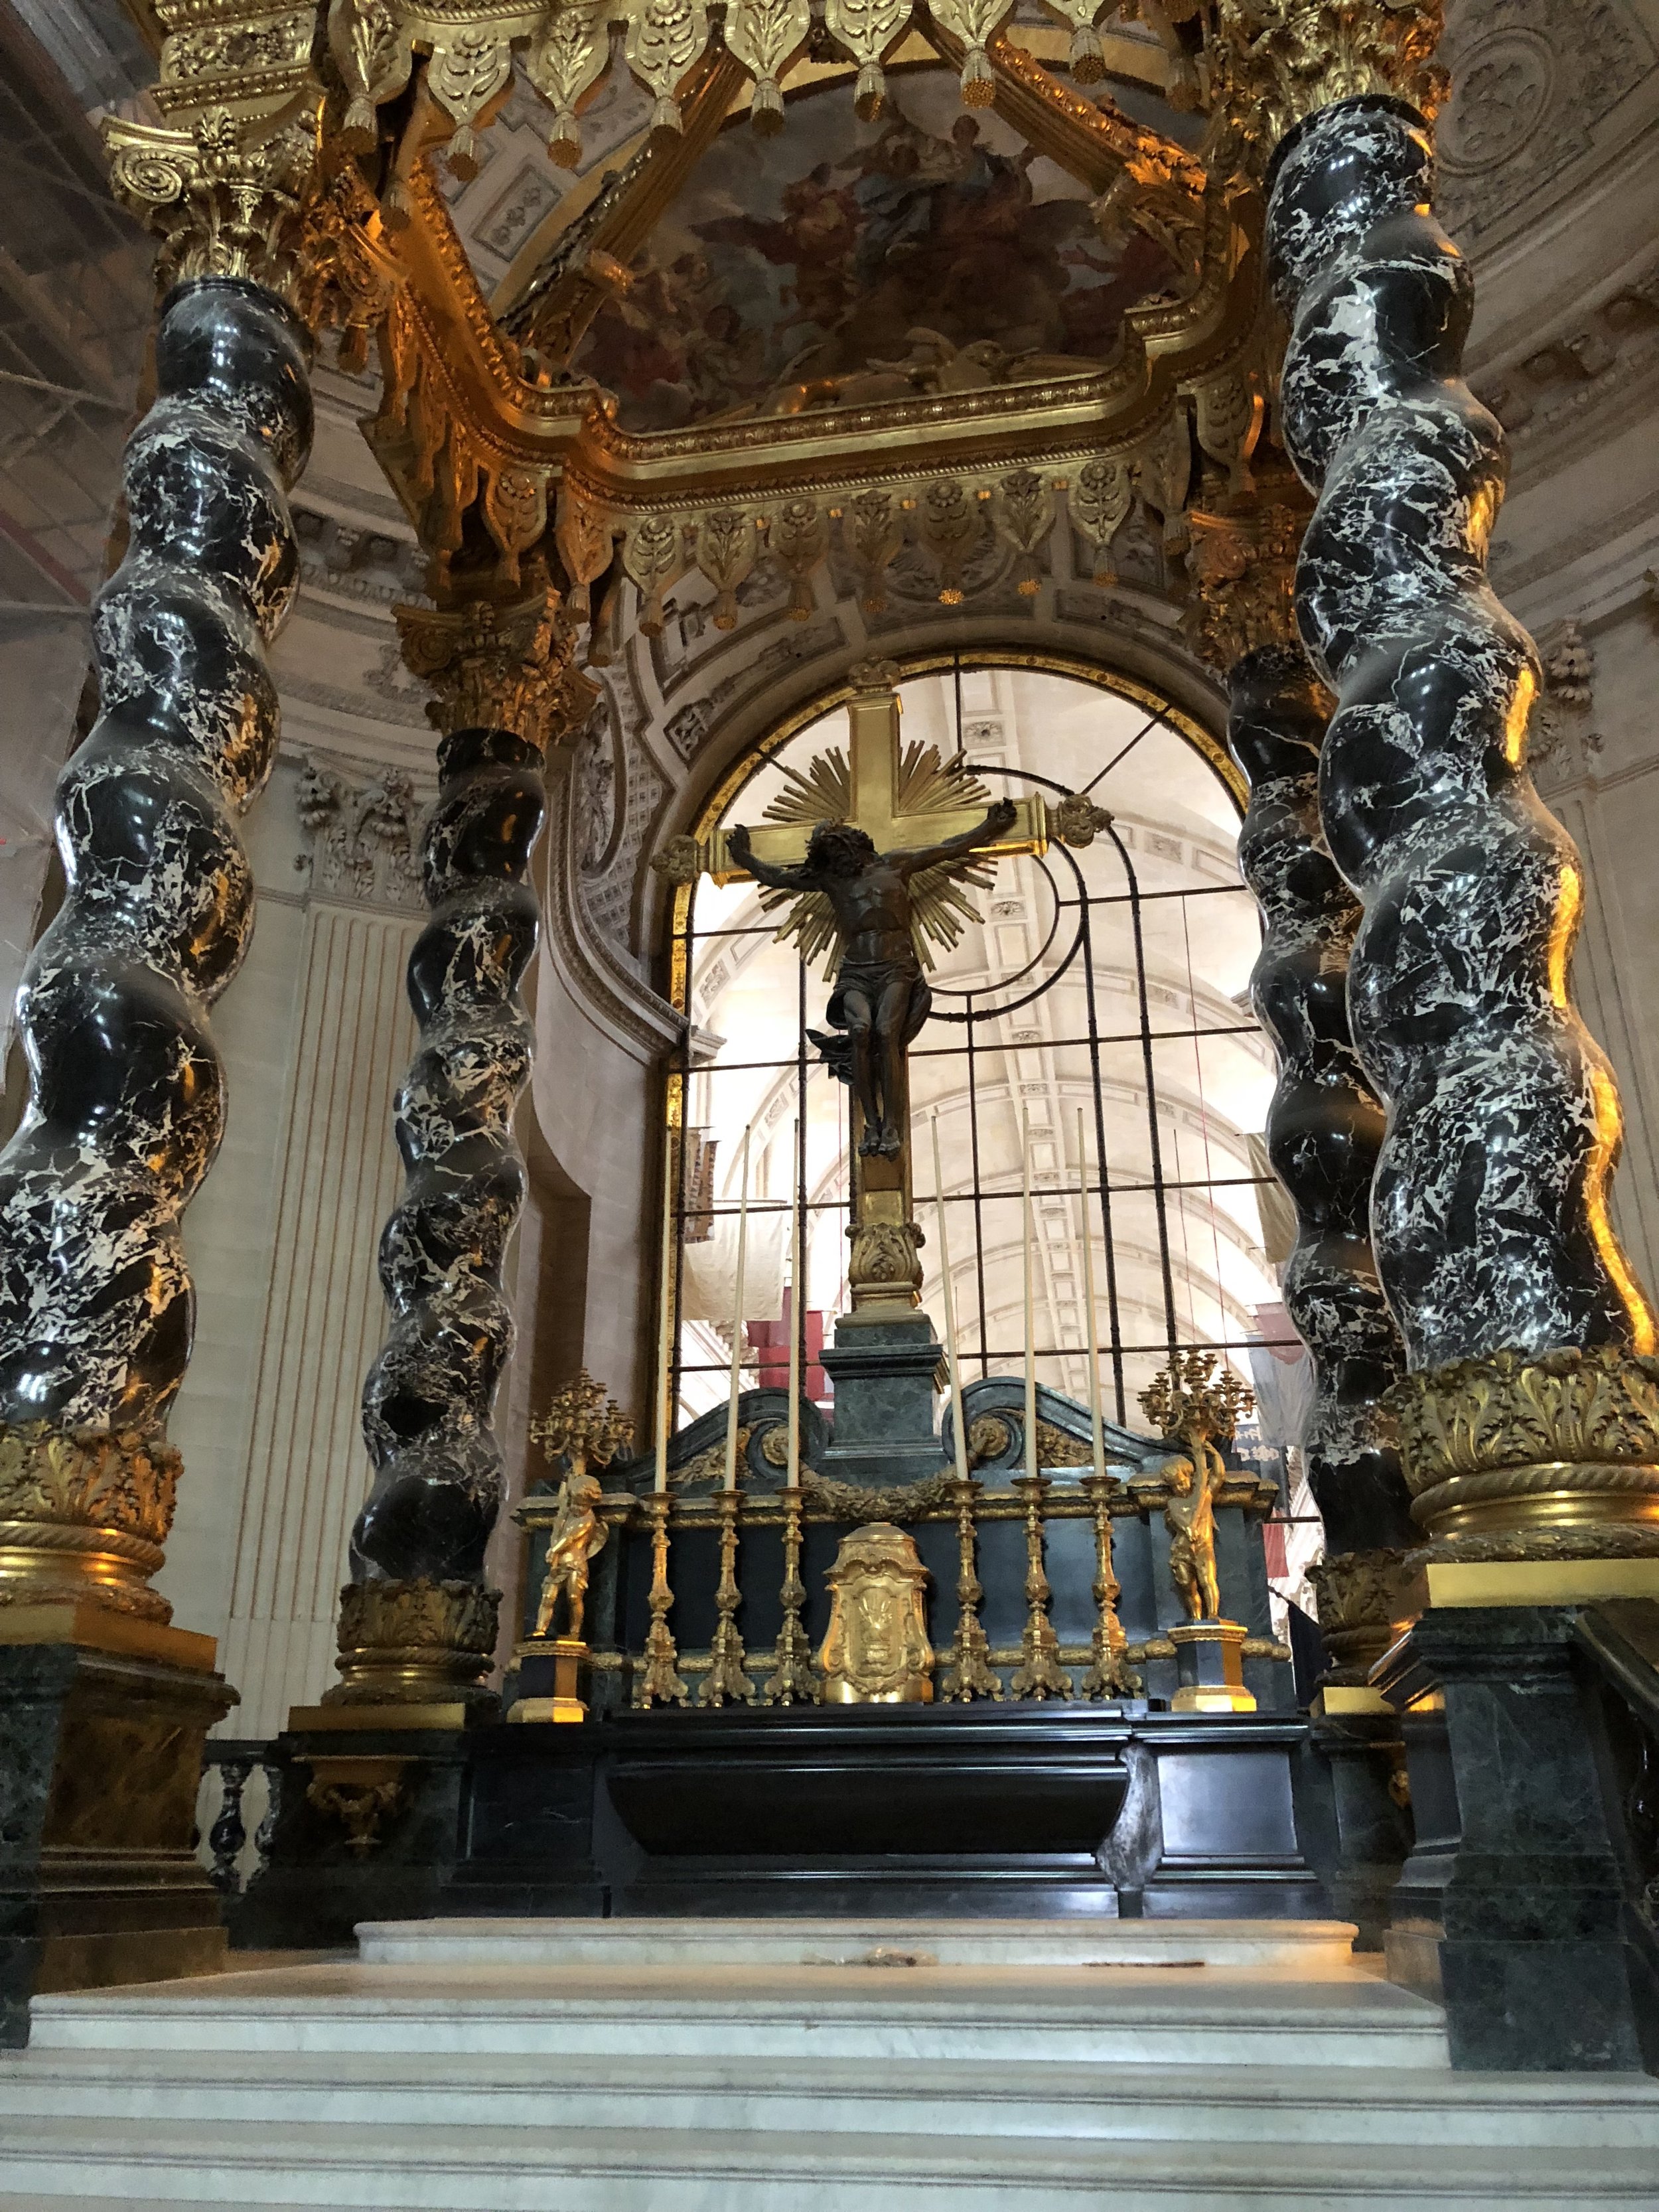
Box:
1206;0;1447;179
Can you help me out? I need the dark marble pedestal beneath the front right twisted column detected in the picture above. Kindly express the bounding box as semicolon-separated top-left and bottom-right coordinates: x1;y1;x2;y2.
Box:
1372;1606;1659;2071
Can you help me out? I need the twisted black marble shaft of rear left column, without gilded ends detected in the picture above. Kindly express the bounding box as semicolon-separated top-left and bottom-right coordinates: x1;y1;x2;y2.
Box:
352;630;549;1610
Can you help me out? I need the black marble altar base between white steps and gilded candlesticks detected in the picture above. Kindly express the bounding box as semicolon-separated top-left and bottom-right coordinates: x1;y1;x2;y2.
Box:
435;1703;1327;1918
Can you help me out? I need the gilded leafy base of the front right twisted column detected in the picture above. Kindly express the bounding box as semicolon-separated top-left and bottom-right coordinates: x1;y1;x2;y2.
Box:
1389;1345;1659;1566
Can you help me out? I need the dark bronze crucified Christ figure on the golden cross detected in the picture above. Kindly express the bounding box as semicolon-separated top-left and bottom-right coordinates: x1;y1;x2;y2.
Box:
725;798;1017;1159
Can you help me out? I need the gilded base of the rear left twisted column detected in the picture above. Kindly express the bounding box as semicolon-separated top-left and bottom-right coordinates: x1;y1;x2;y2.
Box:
323;1582;502;1710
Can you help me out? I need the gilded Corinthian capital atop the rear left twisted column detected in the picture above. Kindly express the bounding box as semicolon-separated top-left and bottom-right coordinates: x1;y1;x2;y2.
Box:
396;586;599;752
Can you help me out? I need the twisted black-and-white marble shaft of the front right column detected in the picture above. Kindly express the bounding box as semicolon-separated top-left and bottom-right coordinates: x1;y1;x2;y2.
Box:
1267;98;1652;1371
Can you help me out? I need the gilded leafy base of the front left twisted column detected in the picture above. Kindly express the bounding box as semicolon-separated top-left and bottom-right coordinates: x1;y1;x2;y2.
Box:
0;1420;181;1628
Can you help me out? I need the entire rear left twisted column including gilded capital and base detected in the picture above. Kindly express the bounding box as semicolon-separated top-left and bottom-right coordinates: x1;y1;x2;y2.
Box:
330;589;595;1701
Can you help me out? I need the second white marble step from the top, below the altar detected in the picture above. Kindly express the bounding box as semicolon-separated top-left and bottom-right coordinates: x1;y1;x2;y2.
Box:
31;1964;1447;2077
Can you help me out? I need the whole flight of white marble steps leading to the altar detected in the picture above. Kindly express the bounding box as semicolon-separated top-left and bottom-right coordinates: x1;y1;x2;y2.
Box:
0;1920;1659;2212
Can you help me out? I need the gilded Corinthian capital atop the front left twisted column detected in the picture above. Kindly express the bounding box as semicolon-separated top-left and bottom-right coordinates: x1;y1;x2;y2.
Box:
104;106;321;297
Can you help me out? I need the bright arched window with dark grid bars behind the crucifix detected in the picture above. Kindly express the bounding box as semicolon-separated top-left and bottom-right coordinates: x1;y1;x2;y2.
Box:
672;657;1279;1427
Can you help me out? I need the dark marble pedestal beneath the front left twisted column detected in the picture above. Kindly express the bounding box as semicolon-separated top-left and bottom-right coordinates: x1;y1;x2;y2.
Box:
0;1621;237;2044
